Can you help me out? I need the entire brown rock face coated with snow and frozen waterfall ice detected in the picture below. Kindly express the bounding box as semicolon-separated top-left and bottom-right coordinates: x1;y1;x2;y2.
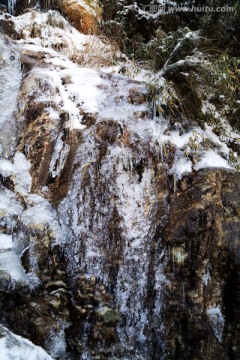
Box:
0;7;240;360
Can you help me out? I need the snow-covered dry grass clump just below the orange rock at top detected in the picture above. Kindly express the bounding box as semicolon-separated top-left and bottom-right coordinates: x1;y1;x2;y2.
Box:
14;10;117;68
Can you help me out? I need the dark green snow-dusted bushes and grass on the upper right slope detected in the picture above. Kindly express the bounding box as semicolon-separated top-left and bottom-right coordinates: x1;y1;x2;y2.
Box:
98;0;240;161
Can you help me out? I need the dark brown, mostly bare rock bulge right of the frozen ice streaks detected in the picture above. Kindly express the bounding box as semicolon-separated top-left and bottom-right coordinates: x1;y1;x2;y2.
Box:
162;171;240;359
